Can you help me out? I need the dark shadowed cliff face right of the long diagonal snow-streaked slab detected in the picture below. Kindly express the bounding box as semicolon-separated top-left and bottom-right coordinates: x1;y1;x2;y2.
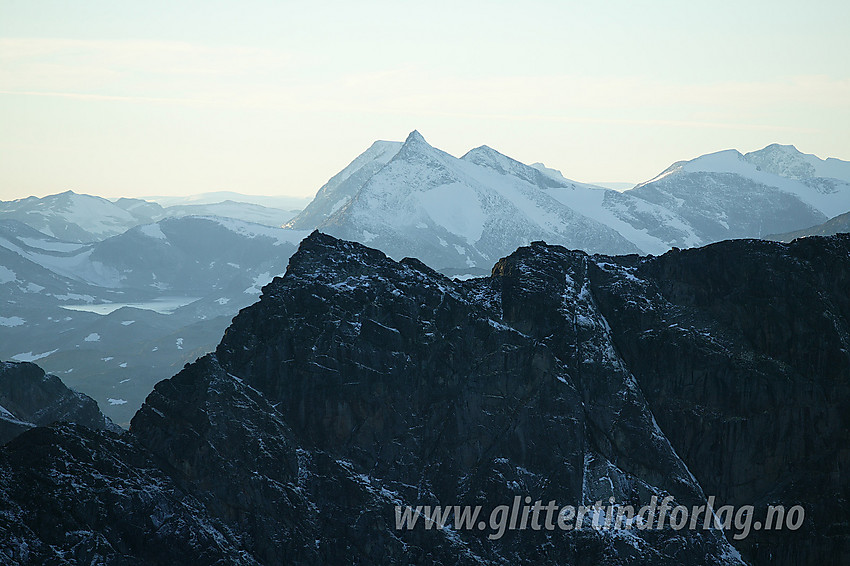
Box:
592;235;850;564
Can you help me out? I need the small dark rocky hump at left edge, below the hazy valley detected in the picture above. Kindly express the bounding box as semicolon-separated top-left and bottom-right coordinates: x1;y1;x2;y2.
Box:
0;362;121;444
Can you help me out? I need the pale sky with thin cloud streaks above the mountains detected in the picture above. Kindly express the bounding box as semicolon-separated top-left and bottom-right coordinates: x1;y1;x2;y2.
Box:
0;0;850;200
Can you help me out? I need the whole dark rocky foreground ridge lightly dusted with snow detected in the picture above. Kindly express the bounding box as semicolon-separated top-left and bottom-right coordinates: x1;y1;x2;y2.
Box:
0;232;850;566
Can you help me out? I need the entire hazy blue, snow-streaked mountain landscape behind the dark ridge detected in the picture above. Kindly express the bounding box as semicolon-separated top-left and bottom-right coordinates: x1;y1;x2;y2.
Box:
0;135;850;426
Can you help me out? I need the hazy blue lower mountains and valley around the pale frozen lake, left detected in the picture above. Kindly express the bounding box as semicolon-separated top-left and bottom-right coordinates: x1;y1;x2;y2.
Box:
0;217;307;425
